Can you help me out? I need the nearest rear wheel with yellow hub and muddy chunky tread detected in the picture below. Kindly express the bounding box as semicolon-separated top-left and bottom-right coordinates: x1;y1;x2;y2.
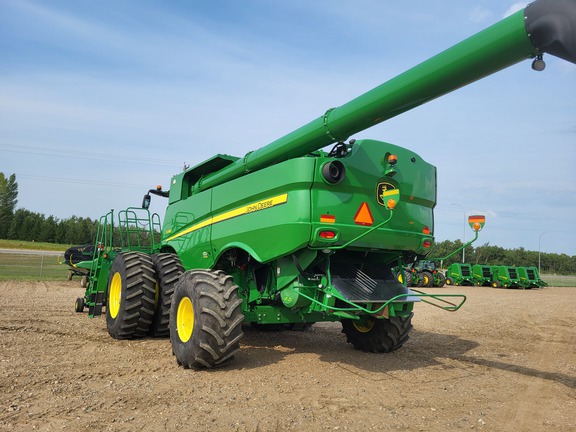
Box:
170;270;244;368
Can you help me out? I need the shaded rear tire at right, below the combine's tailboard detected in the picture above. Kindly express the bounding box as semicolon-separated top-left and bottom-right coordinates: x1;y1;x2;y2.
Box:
342;313;414;352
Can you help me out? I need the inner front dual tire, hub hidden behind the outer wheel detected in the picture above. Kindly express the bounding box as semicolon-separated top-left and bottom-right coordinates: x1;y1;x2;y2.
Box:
150;253;184;337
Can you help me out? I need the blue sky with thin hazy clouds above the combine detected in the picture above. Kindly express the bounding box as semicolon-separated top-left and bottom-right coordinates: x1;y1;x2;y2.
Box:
0;0;576;255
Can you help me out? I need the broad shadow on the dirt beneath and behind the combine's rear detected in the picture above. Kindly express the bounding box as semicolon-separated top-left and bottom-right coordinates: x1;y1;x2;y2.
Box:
225;323;478;372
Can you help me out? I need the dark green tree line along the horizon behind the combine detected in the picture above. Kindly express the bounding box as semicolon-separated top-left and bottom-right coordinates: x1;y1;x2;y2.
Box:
0;172;576;274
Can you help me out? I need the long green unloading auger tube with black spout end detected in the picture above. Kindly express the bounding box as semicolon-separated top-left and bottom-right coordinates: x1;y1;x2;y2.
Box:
195;0;576;191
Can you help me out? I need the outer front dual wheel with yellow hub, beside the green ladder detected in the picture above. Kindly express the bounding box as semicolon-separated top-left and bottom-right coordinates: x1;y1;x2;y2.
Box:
106;252;156;339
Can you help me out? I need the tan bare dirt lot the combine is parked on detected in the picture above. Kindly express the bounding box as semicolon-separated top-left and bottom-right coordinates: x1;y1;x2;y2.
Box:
0;280;576;432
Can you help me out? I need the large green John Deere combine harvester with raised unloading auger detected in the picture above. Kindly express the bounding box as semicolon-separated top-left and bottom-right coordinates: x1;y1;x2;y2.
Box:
77;0;576;368
